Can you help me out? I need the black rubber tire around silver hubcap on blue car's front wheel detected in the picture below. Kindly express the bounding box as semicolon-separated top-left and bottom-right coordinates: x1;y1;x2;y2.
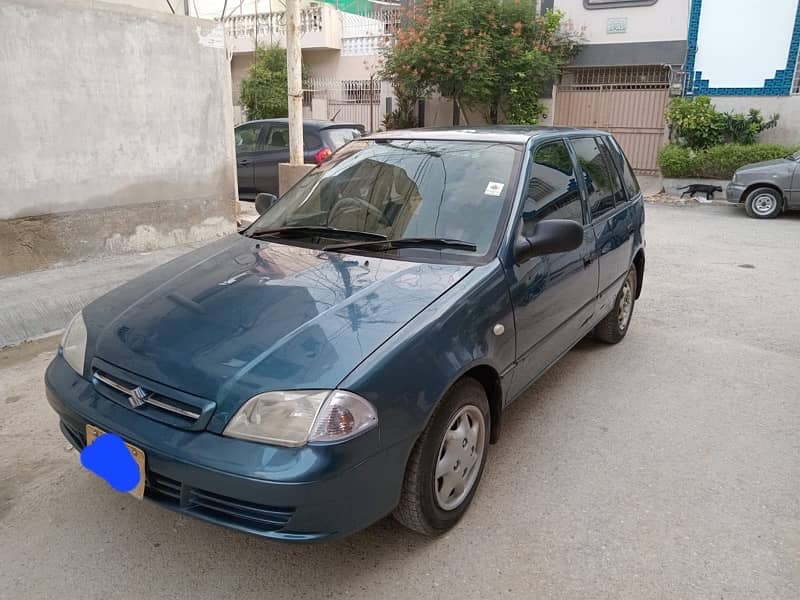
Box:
392;378;491;535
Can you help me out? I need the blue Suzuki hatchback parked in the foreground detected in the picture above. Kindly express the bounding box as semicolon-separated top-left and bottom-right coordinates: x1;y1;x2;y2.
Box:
46;127;645;541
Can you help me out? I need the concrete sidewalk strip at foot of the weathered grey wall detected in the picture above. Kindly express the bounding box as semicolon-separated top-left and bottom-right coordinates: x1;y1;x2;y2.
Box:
0;243;203;348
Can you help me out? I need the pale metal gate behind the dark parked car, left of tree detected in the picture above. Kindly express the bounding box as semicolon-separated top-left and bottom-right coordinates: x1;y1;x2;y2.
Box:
303;78;386;132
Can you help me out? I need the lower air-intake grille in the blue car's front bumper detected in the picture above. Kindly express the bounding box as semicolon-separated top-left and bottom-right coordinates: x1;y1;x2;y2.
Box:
145;470;294;532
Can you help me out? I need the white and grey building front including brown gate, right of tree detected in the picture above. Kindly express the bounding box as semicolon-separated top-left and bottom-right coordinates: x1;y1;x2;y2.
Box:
543;0;689;175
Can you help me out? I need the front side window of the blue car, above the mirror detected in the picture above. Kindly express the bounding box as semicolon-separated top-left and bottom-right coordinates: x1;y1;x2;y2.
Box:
522;140;583;236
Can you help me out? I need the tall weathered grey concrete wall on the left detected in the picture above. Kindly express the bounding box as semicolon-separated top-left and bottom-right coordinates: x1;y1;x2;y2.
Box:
0;0;236;276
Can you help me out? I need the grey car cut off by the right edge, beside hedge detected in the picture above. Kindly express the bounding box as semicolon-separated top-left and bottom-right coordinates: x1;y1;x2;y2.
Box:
726;152;800;219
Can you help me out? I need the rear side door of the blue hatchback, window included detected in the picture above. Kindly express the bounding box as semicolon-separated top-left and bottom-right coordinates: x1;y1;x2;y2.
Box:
570;136;634;315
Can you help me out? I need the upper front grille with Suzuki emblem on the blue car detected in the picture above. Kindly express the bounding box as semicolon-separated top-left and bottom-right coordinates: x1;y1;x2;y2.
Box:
92;361;214;430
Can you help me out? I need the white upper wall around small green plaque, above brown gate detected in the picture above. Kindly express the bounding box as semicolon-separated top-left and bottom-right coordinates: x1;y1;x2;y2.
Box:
554;0;692;44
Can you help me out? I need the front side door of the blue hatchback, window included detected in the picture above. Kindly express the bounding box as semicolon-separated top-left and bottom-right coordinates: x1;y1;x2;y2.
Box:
507;140;598;397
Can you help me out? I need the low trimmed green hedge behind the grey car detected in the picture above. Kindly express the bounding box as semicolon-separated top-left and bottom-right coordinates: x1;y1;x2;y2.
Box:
658;144;800;179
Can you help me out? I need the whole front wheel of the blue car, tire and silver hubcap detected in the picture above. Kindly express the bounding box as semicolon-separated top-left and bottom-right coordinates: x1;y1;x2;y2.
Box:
393;378;490;535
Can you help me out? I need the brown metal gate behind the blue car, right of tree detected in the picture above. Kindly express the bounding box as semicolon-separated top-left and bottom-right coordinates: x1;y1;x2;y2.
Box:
553;65;671;175
